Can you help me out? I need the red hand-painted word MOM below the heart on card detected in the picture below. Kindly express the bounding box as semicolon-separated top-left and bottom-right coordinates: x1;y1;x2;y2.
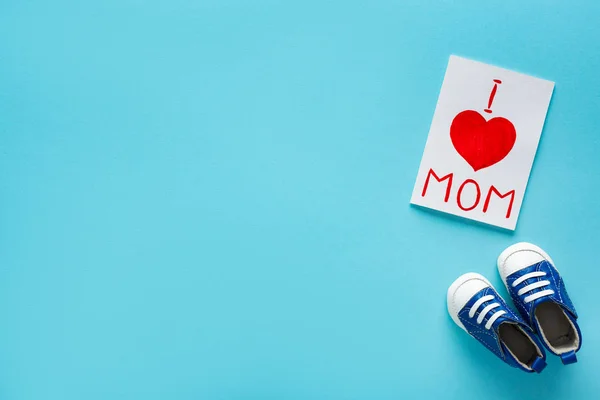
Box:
421;168;515;218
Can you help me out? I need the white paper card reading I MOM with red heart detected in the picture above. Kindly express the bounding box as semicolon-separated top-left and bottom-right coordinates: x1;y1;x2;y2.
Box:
411;56;554;230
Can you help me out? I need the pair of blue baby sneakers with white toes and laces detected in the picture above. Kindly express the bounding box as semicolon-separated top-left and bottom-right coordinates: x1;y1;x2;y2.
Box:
448;243;581;372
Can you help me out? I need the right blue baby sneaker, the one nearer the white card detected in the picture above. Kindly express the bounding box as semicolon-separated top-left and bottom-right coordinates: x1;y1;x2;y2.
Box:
498;243;581;364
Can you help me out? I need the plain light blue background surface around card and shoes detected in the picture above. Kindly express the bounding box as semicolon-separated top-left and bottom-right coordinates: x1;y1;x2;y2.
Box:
0;0;600;400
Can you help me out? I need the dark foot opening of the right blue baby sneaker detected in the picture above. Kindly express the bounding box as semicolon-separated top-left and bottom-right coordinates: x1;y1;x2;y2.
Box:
535;302;579;354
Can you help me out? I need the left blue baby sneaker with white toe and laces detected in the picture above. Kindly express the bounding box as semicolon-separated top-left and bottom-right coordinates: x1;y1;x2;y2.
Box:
448;273;546;372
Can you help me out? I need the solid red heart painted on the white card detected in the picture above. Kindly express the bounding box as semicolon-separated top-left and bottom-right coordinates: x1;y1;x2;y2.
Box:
450;110;517;171
